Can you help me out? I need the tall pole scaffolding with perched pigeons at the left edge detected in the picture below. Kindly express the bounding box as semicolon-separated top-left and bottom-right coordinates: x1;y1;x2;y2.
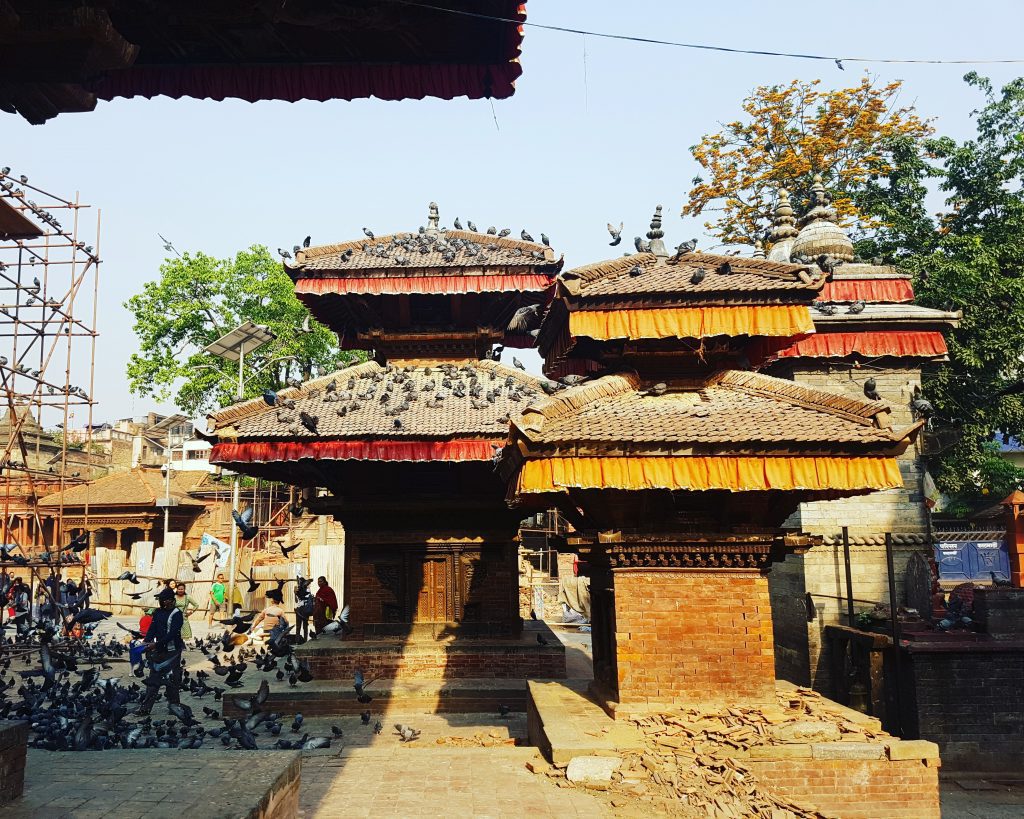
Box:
0;167;100;560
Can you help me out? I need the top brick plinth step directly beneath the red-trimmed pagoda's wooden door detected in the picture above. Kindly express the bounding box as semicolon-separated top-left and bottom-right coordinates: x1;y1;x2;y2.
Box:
295;621;565;682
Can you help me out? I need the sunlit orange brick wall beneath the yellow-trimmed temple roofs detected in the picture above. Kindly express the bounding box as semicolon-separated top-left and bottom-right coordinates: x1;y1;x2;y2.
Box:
613;569;775;708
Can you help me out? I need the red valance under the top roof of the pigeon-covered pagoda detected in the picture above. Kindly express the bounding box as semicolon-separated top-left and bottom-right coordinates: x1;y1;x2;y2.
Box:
295;273;554;296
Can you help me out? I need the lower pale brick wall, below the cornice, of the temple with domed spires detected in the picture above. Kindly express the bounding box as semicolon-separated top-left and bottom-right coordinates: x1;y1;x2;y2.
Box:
768;537;928;694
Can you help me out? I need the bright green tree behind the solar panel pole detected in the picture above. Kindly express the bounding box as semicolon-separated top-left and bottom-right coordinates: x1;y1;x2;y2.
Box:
125;245;356;417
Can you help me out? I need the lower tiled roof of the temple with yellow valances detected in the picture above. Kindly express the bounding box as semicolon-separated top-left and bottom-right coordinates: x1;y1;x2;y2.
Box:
513;371;916;449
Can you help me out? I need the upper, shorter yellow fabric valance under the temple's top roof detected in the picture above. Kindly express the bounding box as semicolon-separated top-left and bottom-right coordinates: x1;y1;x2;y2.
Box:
569;304;814;341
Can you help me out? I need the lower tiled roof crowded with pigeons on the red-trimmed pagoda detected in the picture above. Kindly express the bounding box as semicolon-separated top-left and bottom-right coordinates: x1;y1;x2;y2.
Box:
210;360;543;441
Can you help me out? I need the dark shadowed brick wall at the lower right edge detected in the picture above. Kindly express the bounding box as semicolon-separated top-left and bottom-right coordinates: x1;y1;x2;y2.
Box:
903;641;1024;772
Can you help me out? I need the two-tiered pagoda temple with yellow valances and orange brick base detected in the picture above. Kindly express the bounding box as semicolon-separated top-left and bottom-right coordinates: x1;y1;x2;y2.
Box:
500;210;924;713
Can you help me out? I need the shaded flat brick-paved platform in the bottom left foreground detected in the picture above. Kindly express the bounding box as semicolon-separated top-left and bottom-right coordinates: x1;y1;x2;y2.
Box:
2;749;302;819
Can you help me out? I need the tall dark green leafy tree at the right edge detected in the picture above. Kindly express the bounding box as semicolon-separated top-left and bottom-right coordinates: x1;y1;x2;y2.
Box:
895;73;1024;503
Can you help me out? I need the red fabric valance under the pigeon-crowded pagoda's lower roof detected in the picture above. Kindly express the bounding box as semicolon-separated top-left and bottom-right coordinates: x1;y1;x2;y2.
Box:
210;439;495;468
